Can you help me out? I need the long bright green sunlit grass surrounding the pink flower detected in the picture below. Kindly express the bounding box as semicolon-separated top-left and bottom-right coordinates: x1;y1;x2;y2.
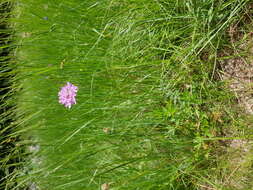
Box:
0;0;250;190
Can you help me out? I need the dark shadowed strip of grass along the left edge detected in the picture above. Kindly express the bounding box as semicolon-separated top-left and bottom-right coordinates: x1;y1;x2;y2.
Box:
0;1;21;190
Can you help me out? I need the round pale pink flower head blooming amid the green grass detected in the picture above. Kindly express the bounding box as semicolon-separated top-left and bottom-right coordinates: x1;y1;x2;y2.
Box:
58;82;78;108
